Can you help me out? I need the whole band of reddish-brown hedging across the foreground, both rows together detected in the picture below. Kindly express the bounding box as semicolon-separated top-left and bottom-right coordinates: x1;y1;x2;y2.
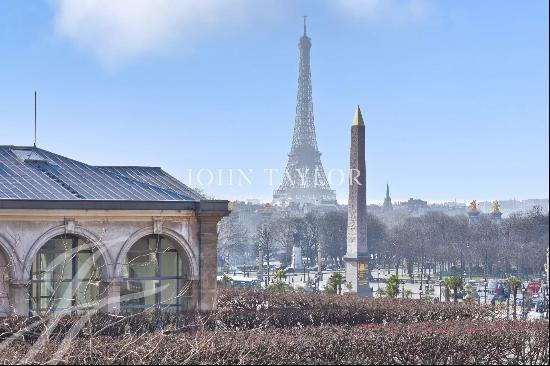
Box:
0;290;548;364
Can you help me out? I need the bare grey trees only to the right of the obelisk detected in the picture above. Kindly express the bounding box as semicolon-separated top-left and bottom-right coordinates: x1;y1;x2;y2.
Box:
386;208;549;276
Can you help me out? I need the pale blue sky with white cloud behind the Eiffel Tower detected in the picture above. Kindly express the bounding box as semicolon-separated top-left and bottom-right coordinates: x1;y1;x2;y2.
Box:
0;0;549;201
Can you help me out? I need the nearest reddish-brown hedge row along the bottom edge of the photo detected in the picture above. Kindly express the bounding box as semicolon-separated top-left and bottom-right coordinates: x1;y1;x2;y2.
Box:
0;321;548;365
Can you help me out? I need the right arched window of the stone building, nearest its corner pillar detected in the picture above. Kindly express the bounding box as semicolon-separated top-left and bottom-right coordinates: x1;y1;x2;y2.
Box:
120;235;192;311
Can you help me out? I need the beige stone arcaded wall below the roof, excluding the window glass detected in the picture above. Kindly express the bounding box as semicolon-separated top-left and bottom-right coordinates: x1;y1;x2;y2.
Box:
0;201;228;316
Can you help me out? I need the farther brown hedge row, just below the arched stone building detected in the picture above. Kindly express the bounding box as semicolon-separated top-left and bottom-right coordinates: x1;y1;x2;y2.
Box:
0;290;496;341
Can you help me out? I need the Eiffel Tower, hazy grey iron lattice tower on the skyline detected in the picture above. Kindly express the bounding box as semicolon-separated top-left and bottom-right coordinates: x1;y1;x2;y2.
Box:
273;17;336;205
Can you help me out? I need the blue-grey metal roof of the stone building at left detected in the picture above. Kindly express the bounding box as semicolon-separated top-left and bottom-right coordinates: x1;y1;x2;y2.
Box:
0;145;203;202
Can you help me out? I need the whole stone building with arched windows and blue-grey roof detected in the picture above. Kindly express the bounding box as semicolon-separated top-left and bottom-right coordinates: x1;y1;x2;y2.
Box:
0;146;228;316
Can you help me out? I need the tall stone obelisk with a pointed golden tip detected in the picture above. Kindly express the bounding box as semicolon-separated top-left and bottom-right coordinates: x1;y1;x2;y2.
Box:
344;106;372;297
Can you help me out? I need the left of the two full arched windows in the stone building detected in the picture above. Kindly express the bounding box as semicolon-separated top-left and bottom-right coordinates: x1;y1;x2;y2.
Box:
30;235;101;313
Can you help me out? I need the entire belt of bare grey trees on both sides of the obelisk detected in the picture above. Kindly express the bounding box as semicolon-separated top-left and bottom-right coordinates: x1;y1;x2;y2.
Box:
220;208;549;276
